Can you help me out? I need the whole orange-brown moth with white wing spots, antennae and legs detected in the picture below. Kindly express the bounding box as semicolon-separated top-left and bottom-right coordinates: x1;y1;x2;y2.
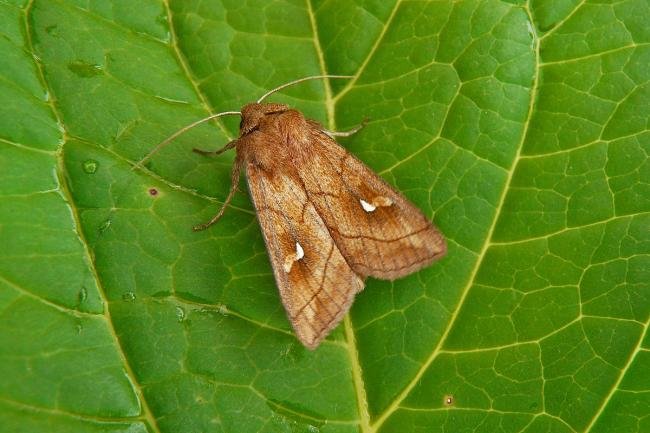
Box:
137;75;446;349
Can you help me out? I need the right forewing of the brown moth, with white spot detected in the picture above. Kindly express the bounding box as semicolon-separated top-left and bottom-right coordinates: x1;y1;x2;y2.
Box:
300;126;446;279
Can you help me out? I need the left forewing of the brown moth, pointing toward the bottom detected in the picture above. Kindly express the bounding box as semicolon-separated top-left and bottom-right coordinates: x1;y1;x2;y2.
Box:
246;152;363;348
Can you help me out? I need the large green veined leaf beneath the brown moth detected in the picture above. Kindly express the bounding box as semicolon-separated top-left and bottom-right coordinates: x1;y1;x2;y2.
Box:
0;0;650;433
